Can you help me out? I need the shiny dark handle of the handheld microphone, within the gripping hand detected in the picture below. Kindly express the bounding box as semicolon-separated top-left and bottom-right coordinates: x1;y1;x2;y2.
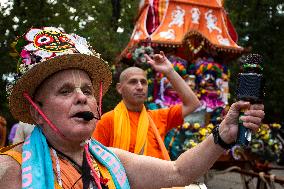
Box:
236;111;251;146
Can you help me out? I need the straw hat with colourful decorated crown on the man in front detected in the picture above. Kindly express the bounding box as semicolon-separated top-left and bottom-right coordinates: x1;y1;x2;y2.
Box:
9;27;112;124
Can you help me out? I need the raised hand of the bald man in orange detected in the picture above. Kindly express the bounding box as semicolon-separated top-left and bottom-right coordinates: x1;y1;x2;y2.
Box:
144;51;173;75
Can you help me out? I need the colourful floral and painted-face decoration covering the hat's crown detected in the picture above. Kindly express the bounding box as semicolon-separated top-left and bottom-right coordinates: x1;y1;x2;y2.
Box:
18;27;93;74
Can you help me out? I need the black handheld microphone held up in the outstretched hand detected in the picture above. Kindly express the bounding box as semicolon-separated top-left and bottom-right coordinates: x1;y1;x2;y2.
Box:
236;54;264;146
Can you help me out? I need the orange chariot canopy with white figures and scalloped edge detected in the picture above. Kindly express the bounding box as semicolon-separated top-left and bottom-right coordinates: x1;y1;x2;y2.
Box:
119;0;245;62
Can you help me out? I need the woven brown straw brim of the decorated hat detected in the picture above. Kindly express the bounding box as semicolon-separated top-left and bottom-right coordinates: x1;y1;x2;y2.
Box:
9;54;112;124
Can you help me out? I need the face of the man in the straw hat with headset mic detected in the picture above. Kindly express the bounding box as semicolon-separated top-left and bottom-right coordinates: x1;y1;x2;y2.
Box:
35;69;98;141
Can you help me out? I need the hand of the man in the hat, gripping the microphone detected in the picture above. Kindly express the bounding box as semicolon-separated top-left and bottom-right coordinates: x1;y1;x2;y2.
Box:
219;101;265;144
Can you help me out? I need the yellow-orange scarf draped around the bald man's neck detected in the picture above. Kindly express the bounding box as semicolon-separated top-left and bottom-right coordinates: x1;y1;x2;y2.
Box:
113;101;170;160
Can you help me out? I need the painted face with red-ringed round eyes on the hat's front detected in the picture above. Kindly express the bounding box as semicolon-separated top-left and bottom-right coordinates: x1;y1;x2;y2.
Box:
34;30;74;52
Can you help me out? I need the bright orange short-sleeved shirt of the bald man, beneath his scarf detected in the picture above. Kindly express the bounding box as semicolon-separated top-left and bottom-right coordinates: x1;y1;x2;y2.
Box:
93;105;183;159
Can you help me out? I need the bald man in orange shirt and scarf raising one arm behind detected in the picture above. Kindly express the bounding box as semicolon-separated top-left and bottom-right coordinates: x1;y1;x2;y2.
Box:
93;51;200;160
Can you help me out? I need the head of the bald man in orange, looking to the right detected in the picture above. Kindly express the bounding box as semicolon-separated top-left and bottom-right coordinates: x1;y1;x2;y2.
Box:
117;69;148;106
